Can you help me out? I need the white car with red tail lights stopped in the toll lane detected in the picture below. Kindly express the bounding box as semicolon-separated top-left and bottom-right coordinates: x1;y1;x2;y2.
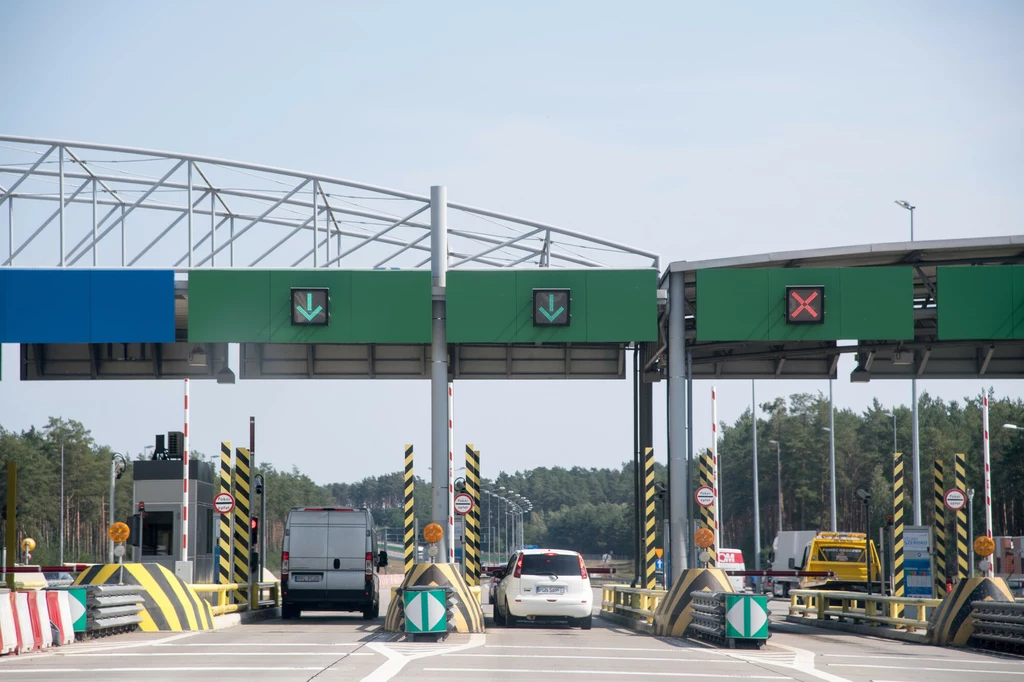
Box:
495;549;594;630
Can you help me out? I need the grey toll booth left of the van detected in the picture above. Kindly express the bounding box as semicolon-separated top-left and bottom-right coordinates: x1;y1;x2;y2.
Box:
129;459;217;584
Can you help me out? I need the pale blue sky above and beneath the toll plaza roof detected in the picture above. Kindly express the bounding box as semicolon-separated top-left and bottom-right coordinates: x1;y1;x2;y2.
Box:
0;1;1024;482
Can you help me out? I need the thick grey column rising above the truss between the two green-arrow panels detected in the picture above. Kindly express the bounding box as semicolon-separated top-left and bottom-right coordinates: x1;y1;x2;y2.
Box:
430;185;453;560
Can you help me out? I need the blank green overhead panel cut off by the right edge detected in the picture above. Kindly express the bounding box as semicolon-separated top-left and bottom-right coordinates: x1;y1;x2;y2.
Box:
936;265;1024;341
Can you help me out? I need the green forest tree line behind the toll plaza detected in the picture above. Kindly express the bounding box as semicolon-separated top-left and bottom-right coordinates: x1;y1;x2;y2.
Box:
0;393;1024;570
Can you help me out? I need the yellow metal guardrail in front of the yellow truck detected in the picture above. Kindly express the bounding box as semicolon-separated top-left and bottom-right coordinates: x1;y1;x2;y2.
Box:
790;590;942;632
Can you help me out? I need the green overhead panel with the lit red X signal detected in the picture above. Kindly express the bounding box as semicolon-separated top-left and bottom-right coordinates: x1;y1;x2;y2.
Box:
696;267;913;341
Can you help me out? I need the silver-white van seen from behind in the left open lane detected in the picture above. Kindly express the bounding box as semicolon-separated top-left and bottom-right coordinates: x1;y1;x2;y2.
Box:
281;507;387;620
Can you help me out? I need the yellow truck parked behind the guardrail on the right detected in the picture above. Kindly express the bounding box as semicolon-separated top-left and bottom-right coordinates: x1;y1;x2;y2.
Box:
796;531;882;591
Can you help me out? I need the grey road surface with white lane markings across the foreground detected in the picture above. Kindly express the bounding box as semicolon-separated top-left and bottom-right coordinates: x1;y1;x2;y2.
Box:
0;590;1024;682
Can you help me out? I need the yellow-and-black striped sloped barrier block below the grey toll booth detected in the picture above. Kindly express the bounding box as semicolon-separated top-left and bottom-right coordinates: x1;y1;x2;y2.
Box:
75;563;213;632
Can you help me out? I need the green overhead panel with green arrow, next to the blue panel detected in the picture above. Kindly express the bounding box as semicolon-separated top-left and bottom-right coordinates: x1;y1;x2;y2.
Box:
188;268;431;344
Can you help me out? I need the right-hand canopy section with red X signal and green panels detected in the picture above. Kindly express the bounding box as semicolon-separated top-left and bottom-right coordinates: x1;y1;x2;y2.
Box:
645;236;1024;381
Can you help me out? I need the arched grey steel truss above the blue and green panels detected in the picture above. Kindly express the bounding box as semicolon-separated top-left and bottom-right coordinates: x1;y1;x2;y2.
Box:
0;135;659;270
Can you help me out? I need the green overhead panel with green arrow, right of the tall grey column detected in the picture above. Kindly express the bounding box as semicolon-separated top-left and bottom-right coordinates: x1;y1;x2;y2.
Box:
445;269;657;343
